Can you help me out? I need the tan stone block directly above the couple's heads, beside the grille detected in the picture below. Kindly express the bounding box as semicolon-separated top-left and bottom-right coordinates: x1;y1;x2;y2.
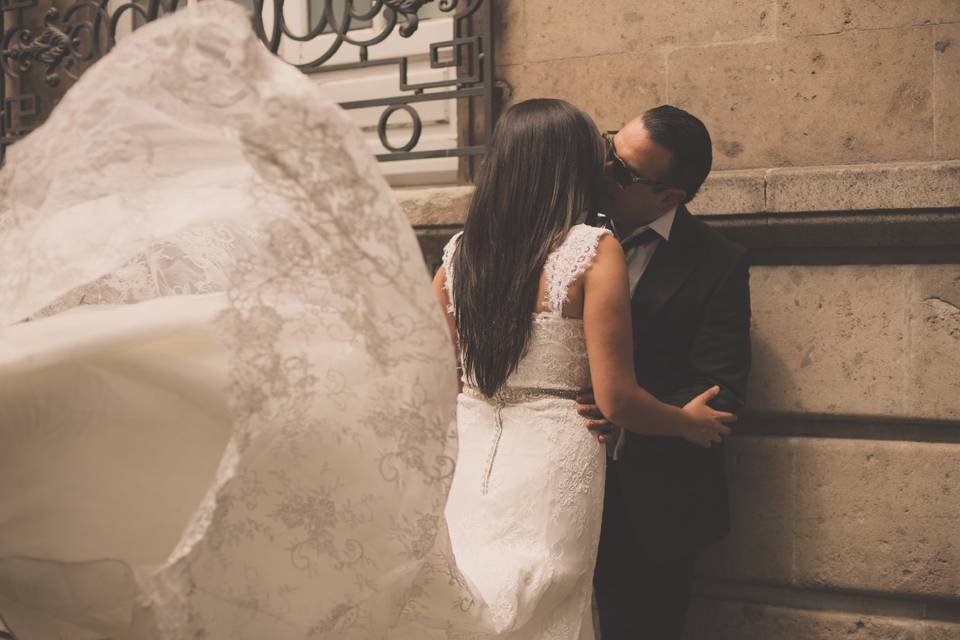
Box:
499;52;666;130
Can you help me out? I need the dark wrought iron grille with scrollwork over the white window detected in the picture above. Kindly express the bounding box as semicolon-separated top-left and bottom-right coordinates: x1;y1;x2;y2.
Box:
0;0;497;164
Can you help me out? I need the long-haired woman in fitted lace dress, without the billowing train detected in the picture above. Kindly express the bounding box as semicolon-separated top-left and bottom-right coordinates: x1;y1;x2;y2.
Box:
396;100;731;640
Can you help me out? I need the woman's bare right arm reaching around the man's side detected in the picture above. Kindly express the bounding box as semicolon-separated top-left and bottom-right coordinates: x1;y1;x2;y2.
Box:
580;235;734;446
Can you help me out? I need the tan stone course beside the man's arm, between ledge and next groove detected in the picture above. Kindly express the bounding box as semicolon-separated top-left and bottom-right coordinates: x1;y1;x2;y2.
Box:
748;265;960;420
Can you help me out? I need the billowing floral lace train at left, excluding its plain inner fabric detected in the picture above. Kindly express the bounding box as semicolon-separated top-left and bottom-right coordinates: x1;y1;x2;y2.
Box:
0;0;471;640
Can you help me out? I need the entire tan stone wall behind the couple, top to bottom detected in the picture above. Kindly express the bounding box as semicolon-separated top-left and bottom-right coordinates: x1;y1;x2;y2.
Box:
399;0;960;640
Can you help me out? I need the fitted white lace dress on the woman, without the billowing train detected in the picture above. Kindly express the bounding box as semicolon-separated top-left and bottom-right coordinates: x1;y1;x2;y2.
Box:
408;225;609;640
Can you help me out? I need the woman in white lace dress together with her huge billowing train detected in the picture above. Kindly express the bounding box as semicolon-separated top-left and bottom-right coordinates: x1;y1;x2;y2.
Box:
0;1;724;640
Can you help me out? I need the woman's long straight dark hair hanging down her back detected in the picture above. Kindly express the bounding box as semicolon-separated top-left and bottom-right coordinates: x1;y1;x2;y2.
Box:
453;99;604;397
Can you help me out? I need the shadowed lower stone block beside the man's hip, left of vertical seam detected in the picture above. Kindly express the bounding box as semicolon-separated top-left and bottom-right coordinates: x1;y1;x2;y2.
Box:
698;438;795;584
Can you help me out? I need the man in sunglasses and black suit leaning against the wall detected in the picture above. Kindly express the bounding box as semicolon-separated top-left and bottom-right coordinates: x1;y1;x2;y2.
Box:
578;105;750;640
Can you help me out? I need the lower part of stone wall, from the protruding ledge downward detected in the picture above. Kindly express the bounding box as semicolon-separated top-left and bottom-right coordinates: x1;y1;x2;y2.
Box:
398;161;960;640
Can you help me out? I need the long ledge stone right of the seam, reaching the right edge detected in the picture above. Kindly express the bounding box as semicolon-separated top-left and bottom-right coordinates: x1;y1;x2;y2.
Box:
766;161;960;212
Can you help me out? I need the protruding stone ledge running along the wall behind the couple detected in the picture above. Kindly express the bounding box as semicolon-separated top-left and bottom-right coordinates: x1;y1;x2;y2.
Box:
395;160;960;226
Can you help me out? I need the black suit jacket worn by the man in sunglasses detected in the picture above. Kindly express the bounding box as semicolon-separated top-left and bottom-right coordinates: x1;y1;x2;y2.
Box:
613;206;750;557
